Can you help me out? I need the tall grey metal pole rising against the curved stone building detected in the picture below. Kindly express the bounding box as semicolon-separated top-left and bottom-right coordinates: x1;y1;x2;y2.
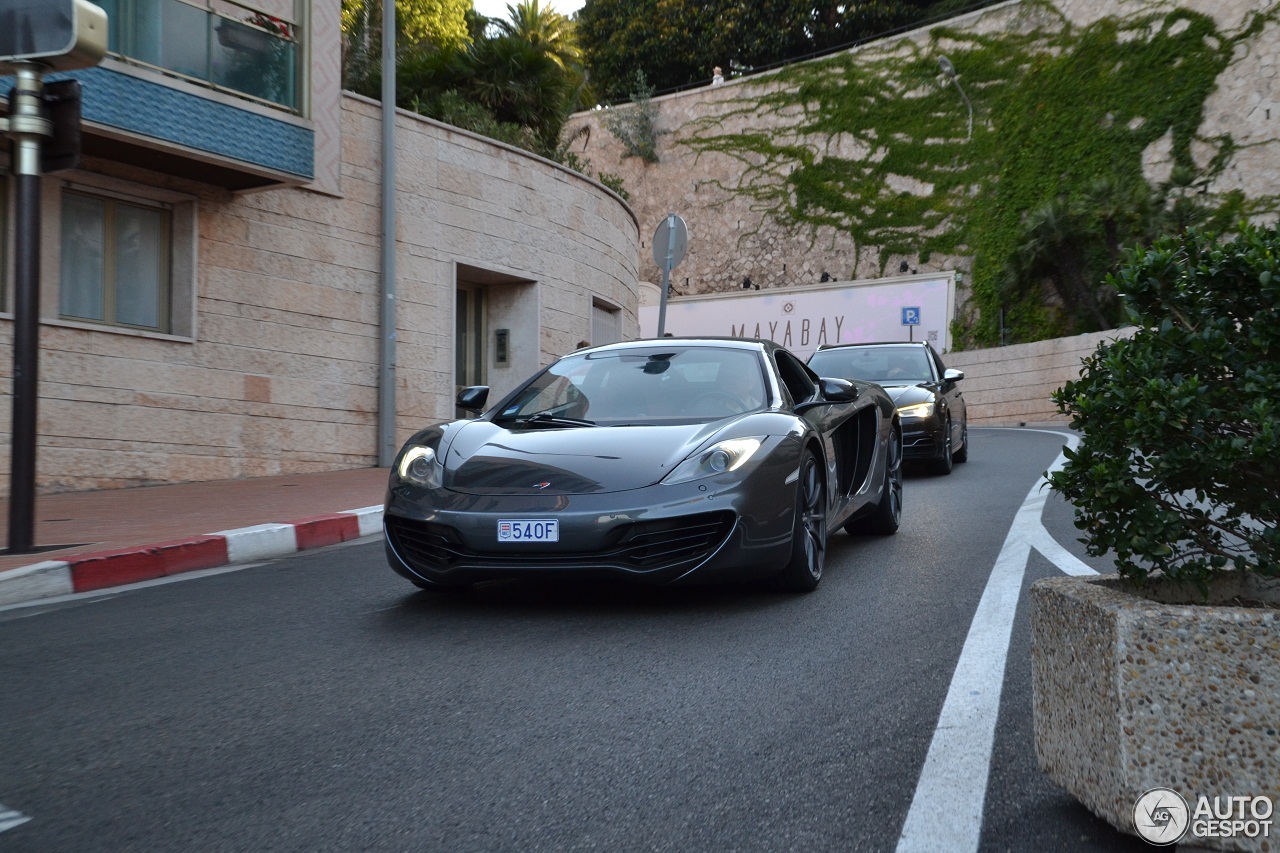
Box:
378;0;398;467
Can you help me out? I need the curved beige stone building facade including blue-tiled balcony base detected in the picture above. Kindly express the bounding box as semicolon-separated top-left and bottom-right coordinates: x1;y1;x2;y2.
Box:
0;0;639;493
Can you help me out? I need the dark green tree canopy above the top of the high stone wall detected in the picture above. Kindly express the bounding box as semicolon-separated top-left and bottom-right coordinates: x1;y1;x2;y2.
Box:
577;0;956;100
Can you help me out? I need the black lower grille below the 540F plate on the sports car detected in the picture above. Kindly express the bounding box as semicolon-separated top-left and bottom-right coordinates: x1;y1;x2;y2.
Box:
385;512;733;571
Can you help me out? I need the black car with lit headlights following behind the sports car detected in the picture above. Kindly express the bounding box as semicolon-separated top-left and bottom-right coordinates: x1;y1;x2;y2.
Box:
809;342;969;474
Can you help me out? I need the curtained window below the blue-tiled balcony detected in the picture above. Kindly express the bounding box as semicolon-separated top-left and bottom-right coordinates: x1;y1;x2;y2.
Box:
58;191;173;333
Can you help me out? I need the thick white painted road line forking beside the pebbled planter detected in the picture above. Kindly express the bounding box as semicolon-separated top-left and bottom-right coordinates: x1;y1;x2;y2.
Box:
897;430;1097;853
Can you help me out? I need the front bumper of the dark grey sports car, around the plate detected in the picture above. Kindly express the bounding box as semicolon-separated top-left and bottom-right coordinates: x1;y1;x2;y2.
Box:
383;450;795;587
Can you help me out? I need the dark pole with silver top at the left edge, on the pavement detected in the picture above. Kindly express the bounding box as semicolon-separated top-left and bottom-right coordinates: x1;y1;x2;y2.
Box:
9;63;52;553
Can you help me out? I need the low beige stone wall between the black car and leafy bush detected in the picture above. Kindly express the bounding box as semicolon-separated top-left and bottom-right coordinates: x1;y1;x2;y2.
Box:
943;329;1133;427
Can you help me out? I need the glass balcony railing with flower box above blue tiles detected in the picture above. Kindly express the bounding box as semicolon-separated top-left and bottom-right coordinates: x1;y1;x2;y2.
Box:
93;0;303;113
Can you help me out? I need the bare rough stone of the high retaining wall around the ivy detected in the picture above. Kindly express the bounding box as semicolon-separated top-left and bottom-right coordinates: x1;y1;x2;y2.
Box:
571;0;1280;311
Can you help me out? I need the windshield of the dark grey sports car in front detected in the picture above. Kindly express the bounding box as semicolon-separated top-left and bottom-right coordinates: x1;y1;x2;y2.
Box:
494;345;767;429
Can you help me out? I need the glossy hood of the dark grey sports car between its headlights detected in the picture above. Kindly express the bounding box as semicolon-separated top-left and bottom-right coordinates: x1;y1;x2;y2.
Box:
444;420;742;494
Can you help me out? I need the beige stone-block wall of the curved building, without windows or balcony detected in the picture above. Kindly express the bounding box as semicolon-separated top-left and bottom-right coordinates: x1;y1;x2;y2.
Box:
0;96;639;493
